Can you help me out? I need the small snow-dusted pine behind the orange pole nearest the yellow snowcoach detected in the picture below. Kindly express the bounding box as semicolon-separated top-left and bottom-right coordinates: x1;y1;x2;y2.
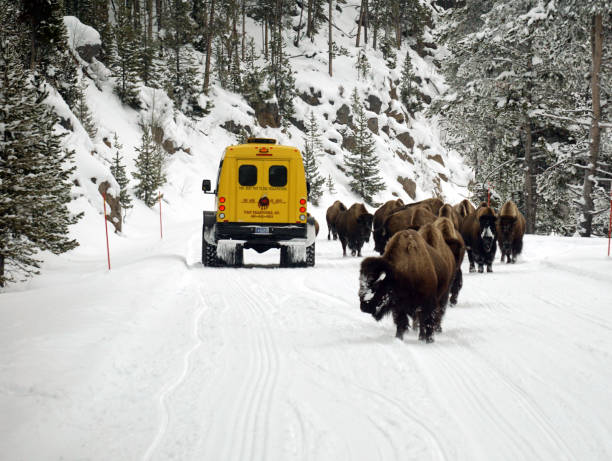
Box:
132;126;166;207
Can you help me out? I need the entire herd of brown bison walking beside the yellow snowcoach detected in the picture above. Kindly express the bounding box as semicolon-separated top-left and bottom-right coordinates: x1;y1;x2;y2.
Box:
326;198;525;342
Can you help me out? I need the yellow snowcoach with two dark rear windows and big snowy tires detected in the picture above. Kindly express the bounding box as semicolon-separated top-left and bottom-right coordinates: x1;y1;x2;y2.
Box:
202;138;315;267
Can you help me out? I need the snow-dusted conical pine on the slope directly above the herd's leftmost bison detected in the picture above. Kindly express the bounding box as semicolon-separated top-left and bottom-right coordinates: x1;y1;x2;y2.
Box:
344;88;385;205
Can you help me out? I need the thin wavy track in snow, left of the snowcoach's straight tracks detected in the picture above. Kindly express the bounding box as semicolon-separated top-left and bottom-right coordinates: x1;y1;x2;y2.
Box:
142;277;208;461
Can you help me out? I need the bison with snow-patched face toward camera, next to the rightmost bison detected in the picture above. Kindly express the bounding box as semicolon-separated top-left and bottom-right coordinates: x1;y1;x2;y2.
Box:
461;203;497;272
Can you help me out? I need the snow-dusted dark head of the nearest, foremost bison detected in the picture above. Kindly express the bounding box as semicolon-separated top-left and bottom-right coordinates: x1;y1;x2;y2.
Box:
359;257;393;320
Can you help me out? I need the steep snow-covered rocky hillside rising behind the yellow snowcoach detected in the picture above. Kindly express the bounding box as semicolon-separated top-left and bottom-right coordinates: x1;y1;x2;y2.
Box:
48;1;471;253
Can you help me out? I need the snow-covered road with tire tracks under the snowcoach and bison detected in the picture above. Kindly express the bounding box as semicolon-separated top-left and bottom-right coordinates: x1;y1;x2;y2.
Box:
0;223;612;461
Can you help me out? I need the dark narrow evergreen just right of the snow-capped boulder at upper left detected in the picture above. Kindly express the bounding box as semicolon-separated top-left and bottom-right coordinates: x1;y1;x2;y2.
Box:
111;2;140;109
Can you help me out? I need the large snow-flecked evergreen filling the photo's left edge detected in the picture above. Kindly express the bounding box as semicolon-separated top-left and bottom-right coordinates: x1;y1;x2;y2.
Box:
0;27;80;286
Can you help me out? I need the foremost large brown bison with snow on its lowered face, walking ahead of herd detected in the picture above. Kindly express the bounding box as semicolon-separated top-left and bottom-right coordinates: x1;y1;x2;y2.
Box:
359;229;448;342
